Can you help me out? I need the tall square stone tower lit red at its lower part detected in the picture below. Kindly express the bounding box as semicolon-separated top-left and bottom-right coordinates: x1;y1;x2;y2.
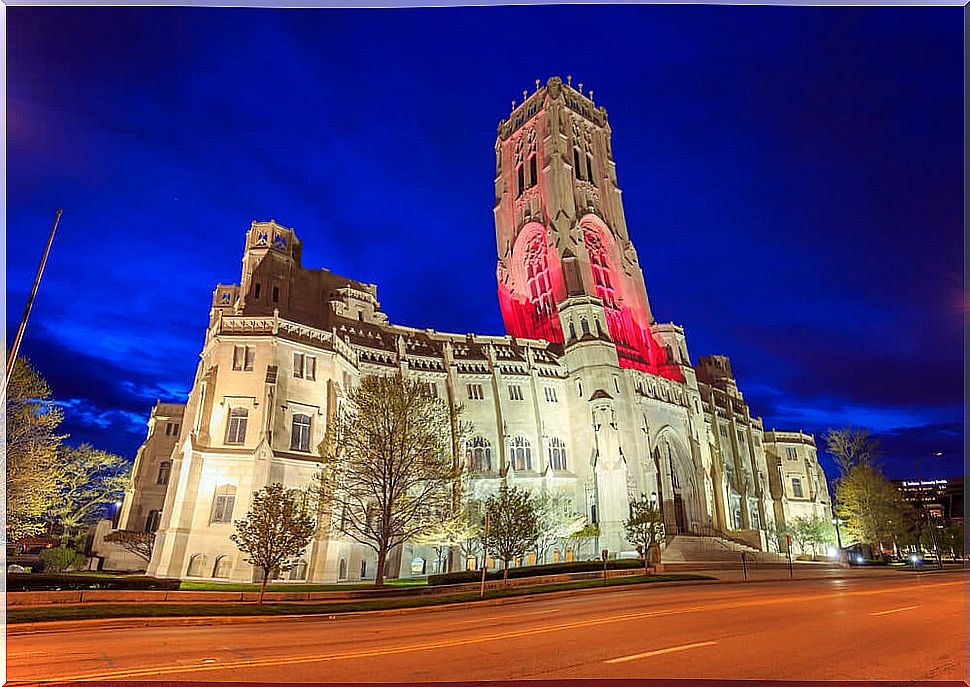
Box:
495;77;683;381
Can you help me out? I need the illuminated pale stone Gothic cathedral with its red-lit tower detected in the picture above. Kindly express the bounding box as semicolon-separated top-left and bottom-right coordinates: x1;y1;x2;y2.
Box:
113;78;827;581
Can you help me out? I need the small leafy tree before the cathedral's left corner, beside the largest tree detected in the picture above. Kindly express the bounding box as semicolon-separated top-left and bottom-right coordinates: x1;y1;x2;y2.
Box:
230;482;316;603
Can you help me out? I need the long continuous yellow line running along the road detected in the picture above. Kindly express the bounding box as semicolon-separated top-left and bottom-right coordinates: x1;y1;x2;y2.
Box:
7;580;965;685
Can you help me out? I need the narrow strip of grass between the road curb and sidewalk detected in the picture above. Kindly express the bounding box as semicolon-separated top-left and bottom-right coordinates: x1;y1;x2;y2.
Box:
7;574;715;625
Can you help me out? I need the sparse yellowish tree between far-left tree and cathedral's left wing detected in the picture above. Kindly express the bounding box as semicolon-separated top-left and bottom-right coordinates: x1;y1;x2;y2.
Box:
47;444;131;542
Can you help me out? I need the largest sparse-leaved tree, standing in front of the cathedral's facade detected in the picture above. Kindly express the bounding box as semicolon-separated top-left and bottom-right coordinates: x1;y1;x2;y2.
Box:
314;374;461;586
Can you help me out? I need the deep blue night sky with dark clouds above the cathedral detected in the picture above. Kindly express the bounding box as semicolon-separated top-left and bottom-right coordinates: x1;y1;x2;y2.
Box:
7;6;966;477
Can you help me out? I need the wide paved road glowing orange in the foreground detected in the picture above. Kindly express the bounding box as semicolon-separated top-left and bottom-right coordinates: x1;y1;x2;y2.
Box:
7;573;964;682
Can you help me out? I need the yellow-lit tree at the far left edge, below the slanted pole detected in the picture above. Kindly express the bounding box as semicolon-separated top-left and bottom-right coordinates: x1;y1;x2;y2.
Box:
4;357;63;542
